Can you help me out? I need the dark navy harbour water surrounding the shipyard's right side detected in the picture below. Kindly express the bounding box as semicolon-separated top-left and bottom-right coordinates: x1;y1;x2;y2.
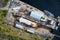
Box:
21;0;60;40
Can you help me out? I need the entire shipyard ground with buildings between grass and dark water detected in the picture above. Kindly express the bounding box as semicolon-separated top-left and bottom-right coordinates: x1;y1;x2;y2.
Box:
0;0;60;40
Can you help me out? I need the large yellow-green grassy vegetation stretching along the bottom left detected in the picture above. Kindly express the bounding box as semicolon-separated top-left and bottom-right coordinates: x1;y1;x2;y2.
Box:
0;10;42;40
